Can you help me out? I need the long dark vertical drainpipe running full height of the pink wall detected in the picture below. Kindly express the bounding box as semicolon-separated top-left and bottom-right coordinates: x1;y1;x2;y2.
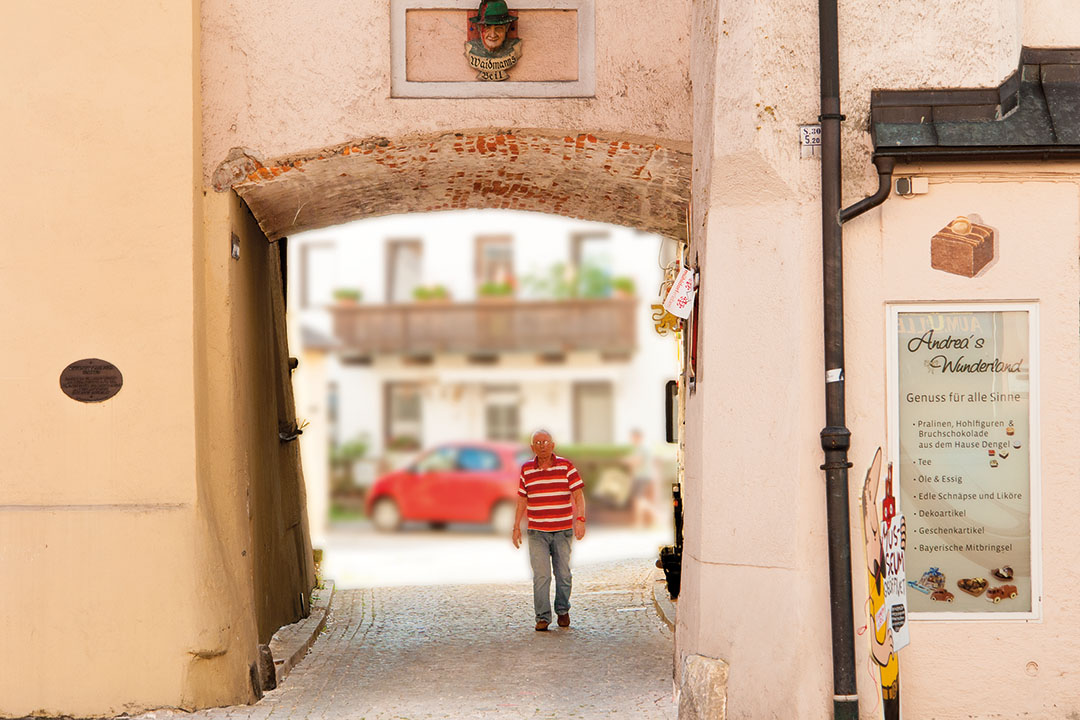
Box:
818;0;859;720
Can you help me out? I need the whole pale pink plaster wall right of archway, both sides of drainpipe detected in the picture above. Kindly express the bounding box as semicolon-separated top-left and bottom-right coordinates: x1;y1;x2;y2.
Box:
676;0;1080;719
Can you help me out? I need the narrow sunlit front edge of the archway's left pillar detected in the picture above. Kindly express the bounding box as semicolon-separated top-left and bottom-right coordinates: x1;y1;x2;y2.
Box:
191;194;261;707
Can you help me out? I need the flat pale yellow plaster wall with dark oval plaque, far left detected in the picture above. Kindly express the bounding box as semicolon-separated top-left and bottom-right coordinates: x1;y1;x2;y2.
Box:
0;0;201;717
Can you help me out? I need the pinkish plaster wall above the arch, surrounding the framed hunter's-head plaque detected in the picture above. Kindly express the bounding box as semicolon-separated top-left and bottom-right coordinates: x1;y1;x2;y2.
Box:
202;0;691;185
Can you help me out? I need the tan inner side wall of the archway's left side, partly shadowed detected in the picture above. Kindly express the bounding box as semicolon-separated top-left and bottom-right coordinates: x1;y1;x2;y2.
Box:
199;192;314;651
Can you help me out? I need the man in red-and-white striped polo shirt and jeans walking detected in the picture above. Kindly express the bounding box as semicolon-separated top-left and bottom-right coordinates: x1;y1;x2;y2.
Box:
510;430;585;630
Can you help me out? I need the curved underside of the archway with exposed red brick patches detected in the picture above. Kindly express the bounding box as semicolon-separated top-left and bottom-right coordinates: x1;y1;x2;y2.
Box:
214;130;691;240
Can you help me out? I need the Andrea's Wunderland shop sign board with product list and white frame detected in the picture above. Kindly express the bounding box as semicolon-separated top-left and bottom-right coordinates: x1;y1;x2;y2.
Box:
889;303;1040;620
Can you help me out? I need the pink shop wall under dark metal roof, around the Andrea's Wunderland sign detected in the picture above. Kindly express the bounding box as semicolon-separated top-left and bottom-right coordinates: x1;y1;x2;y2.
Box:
846;171;1080;720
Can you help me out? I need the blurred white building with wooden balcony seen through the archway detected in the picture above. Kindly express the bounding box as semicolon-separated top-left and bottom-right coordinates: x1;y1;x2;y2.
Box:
288;210;678;507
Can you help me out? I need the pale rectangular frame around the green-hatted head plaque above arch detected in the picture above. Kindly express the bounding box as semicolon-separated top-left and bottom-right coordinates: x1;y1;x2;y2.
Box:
390;0;596;98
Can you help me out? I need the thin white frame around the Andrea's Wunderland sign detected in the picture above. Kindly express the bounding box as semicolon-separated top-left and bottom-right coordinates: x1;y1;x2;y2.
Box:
886;300;1042;623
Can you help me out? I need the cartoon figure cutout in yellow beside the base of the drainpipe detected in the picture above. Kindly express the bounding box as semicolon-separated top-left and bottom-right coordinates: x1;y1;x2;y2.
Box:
862;448;904;720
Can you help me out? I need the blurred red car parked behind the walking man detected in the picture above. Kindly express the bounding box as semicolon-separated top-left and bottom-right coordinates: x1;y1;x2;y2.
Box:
367;443;532;534
